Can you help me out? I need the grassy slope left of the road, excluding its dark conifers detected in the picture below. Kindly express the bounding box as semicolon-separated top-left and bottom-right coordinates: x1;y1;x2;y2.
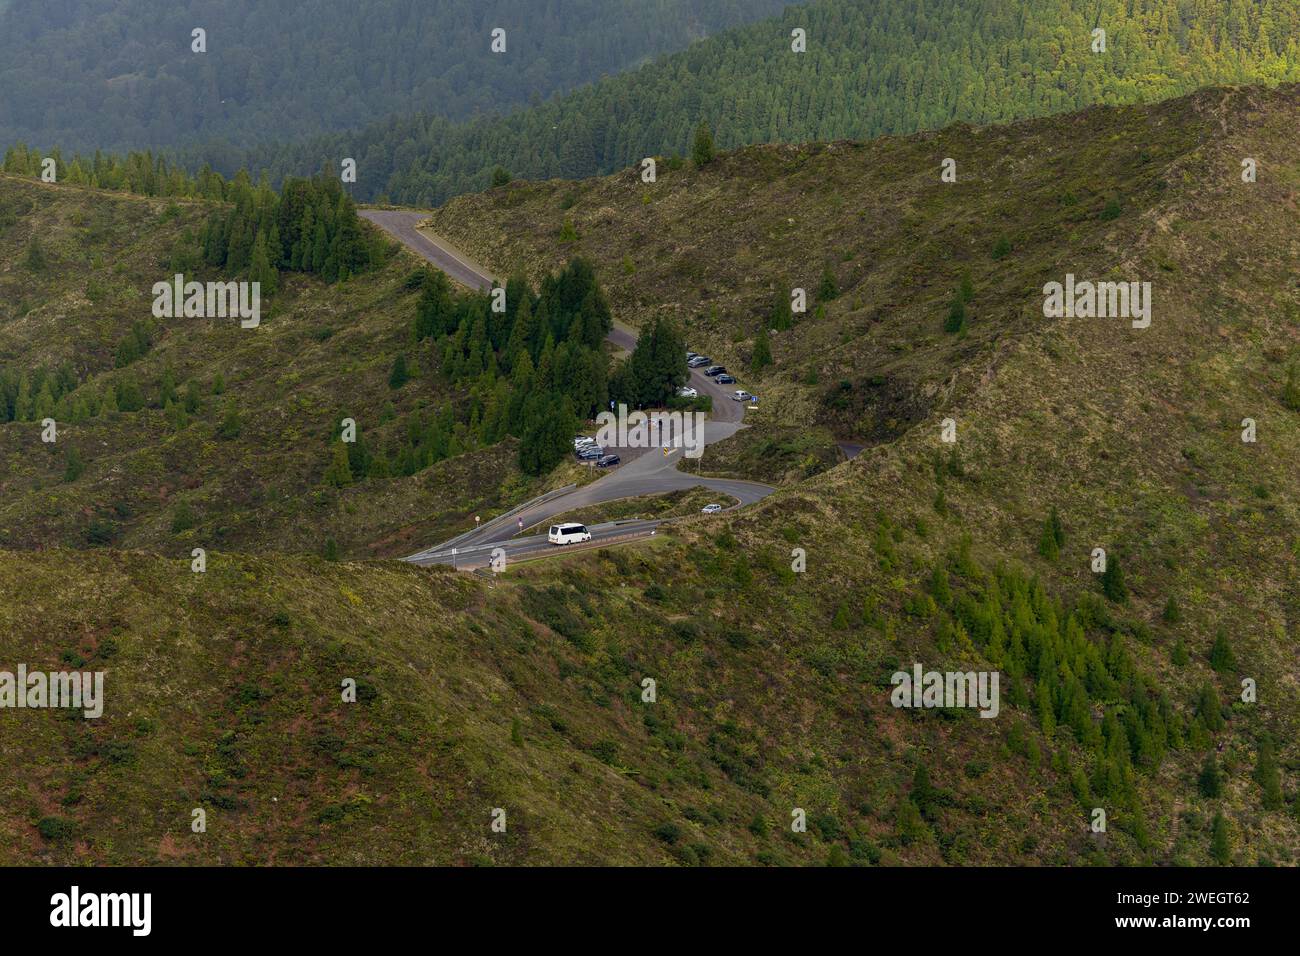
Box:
0;177;546;555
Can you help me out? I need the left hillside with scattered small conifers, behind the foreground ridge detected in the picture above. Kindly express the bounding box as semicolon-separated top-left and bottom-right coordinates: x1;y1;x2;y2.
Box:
0;176;556;555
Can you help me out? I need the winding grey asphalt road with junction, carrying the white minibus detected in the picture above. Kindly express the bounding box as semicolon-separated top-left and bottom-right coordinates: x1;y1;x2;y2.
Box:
360;209;774;568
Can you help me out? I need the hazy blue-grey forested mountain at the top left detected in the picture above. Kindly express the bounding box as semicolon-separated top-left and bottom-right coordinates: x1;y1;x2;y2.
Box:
0;0;785;151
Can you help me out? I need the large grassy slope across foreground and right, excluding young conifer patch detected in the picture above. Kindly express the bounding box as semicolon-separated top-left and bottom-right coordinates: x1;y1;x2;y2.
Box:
0;88;1300;865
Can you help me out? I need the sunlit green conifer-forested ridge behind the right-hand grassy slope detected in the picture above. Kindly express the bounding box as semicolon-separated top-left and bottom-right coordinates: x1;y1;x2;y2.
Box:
183;0;1300;206
